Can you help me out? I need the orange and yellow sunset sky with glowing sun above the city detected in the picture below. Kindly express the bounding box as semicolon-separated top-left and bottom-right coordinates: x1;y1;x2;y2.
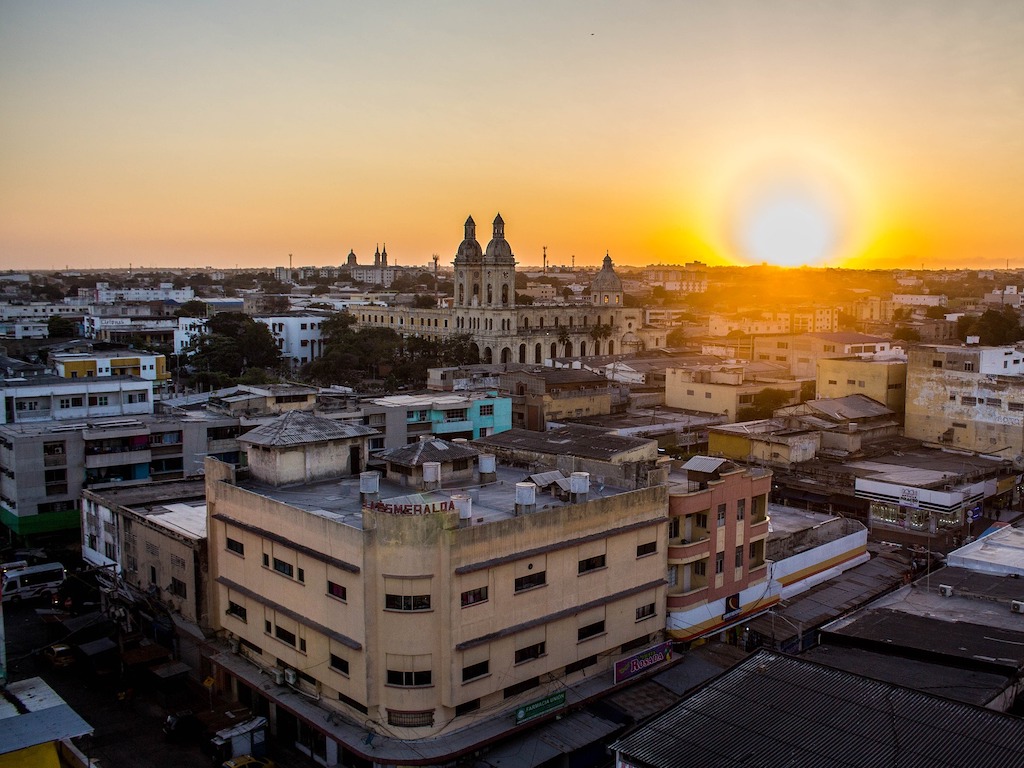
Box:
0;0;1024;269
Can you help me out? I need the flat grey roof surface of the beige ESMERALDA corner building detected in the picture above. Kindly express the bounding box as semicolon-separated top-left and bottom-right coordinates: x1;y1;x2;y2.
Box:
238;465;628;528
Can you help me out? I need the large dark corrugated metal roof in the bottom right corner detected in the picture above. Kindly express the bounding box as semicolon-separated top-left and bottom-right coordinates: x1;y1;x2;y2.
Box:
611;650;1024;768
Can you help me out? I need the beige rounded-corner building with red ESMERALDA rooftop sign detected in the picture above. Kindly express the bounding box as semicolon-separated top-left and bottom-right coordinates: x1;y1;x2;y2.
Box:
206;415;667;765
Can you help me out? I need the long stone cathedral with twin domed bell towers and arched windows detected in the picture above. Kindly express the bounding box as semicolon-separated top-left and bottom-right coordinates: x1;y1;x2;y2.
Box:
355;214;668;365
